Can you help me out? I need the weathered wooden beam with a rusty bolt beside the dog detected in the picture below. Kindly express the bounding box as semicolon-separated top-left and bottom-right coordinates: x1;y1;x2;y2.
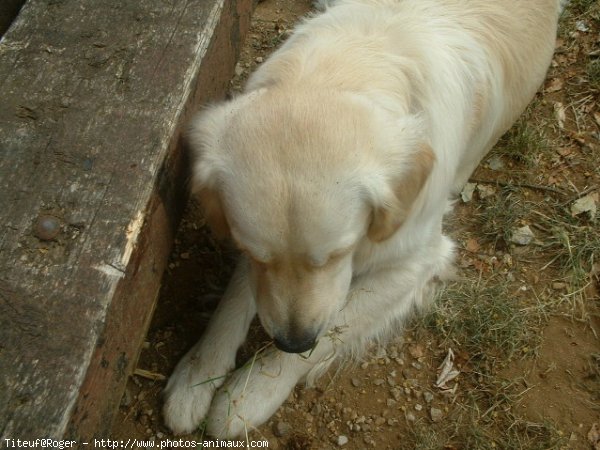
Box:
0;0;252;439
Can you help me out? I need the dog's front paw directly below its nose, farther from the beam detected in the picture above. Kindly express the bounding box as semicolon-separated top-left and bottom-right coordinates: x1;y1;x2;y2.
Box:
206;351;302;439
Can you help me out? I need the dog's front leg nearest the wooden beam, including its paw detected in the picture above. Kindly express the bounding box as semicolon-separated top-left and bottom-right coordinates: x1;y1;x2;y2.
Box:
163;260;256;434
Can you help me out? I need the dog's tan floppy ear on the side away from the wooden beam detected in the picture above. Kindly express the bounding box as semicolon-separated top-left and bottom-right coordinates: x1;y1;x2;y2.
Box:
367;144;435;242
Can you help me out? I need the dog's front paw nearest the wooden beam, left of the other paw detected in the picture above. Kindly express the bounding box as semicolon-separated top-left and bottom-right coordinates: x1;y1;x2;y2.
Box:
163;352;229;434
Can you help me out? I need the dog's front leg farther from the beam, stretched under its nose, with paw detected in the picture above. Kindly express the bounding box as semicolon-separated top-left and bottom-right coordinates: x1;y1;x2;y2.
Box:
207;237;453;438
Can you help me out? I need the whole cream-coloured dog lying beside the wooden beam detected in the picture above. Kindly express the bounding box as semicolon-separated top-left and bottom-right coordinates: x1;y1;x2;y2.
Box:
164;0;560;437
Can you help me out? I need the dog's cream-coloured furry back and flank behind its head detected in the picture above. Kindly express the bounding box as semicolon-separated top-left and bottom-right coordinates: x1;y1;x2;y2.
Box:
248;0;561;192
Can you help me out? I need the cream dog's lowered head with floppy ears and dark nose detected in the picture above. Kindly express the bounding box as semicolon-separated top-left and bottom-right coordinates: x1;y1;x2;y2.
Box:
190;90;434;353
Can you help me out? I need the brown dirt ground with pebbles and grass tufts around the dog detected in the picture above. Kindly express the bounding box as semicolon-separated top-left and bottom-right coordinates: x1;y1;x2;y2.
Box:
112;0;600;450
